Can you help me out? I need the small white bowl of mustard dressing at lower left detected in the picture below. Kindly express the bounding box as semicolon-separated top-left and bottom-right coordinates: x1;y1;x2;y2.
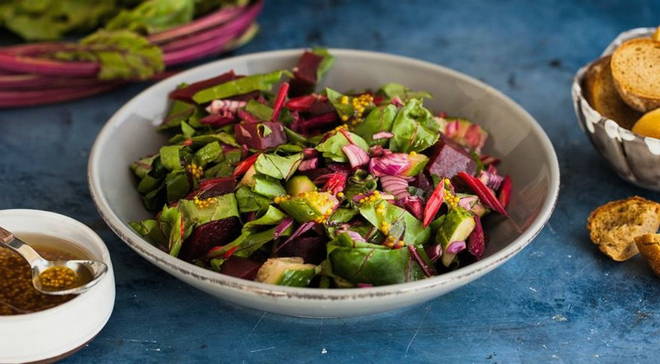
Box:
0;210;115;363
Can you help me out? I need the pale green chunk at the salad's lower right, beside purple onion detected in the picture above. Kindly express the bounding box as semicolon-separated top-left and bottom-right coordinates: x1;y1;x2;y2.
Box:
435;207;476;267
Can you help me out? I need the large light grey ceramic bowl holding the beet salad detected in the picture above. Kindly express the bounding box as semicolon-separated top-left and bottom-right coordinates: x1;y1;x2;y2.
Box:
88;49;559;317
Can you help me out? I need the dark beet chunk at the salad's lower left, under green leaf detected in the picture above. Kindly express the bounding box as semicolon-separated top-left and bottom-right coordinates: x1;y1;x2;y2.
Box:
179;216;241;261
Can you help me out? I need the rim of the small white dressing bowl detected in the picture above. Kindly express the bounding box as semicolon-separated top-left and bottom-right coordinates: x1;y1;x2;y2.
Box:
0;209;114;324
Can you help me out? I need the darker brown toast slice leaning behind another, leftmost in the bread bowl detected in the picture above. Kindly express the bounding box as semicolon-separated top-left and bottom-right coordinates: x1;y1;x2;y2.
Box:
582;56;642;129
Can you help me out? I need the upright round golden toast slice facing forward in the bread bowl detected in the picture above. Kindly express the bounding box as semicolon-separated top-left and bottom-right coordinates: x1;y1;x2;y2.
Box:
610;38;660;112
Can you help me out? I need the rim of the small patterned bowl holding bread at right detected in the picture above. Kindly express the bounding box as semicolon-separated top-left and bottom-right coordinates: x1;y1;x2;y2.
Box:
572;27;660;143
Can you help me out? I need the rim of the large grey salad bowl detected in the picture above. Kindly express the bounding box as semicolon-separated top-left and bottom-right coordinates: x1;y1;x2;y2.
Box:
87;48;560;300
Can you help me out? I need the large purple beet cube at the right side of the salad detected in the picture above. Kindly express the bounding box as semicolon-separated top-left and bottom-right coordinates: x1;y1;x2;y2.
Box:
426;138;477;178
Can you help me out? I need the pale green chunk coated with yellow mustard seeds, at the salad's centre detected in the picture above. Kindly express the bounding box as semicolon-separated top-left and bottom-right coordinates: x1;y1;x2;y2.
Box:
278;191;339;223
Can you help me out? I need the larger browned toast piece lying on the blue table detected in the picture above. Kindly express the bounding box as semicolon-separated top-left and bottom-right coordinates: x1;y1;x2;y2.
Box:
587;196;660;262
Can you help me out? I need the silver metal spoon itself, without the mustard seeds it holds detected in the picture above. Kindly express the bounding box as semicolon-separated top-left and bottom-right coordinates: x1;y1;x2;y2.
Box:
0;227;108;295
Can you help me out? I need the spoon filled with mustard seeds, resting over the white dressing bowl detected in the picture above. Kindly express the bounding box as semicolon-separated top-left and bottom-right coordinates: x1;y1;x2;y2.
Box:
0;227;108;295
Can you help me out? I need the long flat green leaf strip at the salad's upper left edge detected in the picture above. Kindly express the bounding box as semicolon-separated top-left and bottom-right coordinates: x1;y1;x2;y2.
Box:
193;71;289;104
